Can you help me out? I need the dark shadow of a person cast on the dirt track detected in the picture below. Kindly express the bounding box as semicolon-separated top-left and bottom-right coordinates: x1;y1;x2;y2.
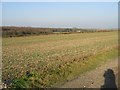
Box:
101;69;117;90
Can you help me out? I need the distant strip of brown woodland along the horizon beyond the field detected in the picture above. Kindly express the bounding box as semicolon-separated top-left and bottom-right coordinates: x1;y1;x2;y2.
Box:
2;26;115;37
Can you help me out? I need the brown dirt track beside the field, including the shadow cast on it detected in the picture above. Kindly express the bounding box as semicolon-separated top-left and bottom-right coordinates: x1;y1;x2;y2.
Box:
60;59;118;88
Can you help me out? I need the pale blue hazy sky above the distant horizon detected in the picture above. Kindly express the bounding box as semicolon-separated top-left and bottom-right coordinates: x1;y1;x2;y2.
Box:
2;2;118;28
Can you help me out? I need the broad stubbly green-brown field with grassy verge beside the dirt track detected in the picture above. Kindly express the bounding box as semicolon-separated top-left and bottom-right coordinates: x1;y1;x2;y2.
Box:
2;31;118;87
